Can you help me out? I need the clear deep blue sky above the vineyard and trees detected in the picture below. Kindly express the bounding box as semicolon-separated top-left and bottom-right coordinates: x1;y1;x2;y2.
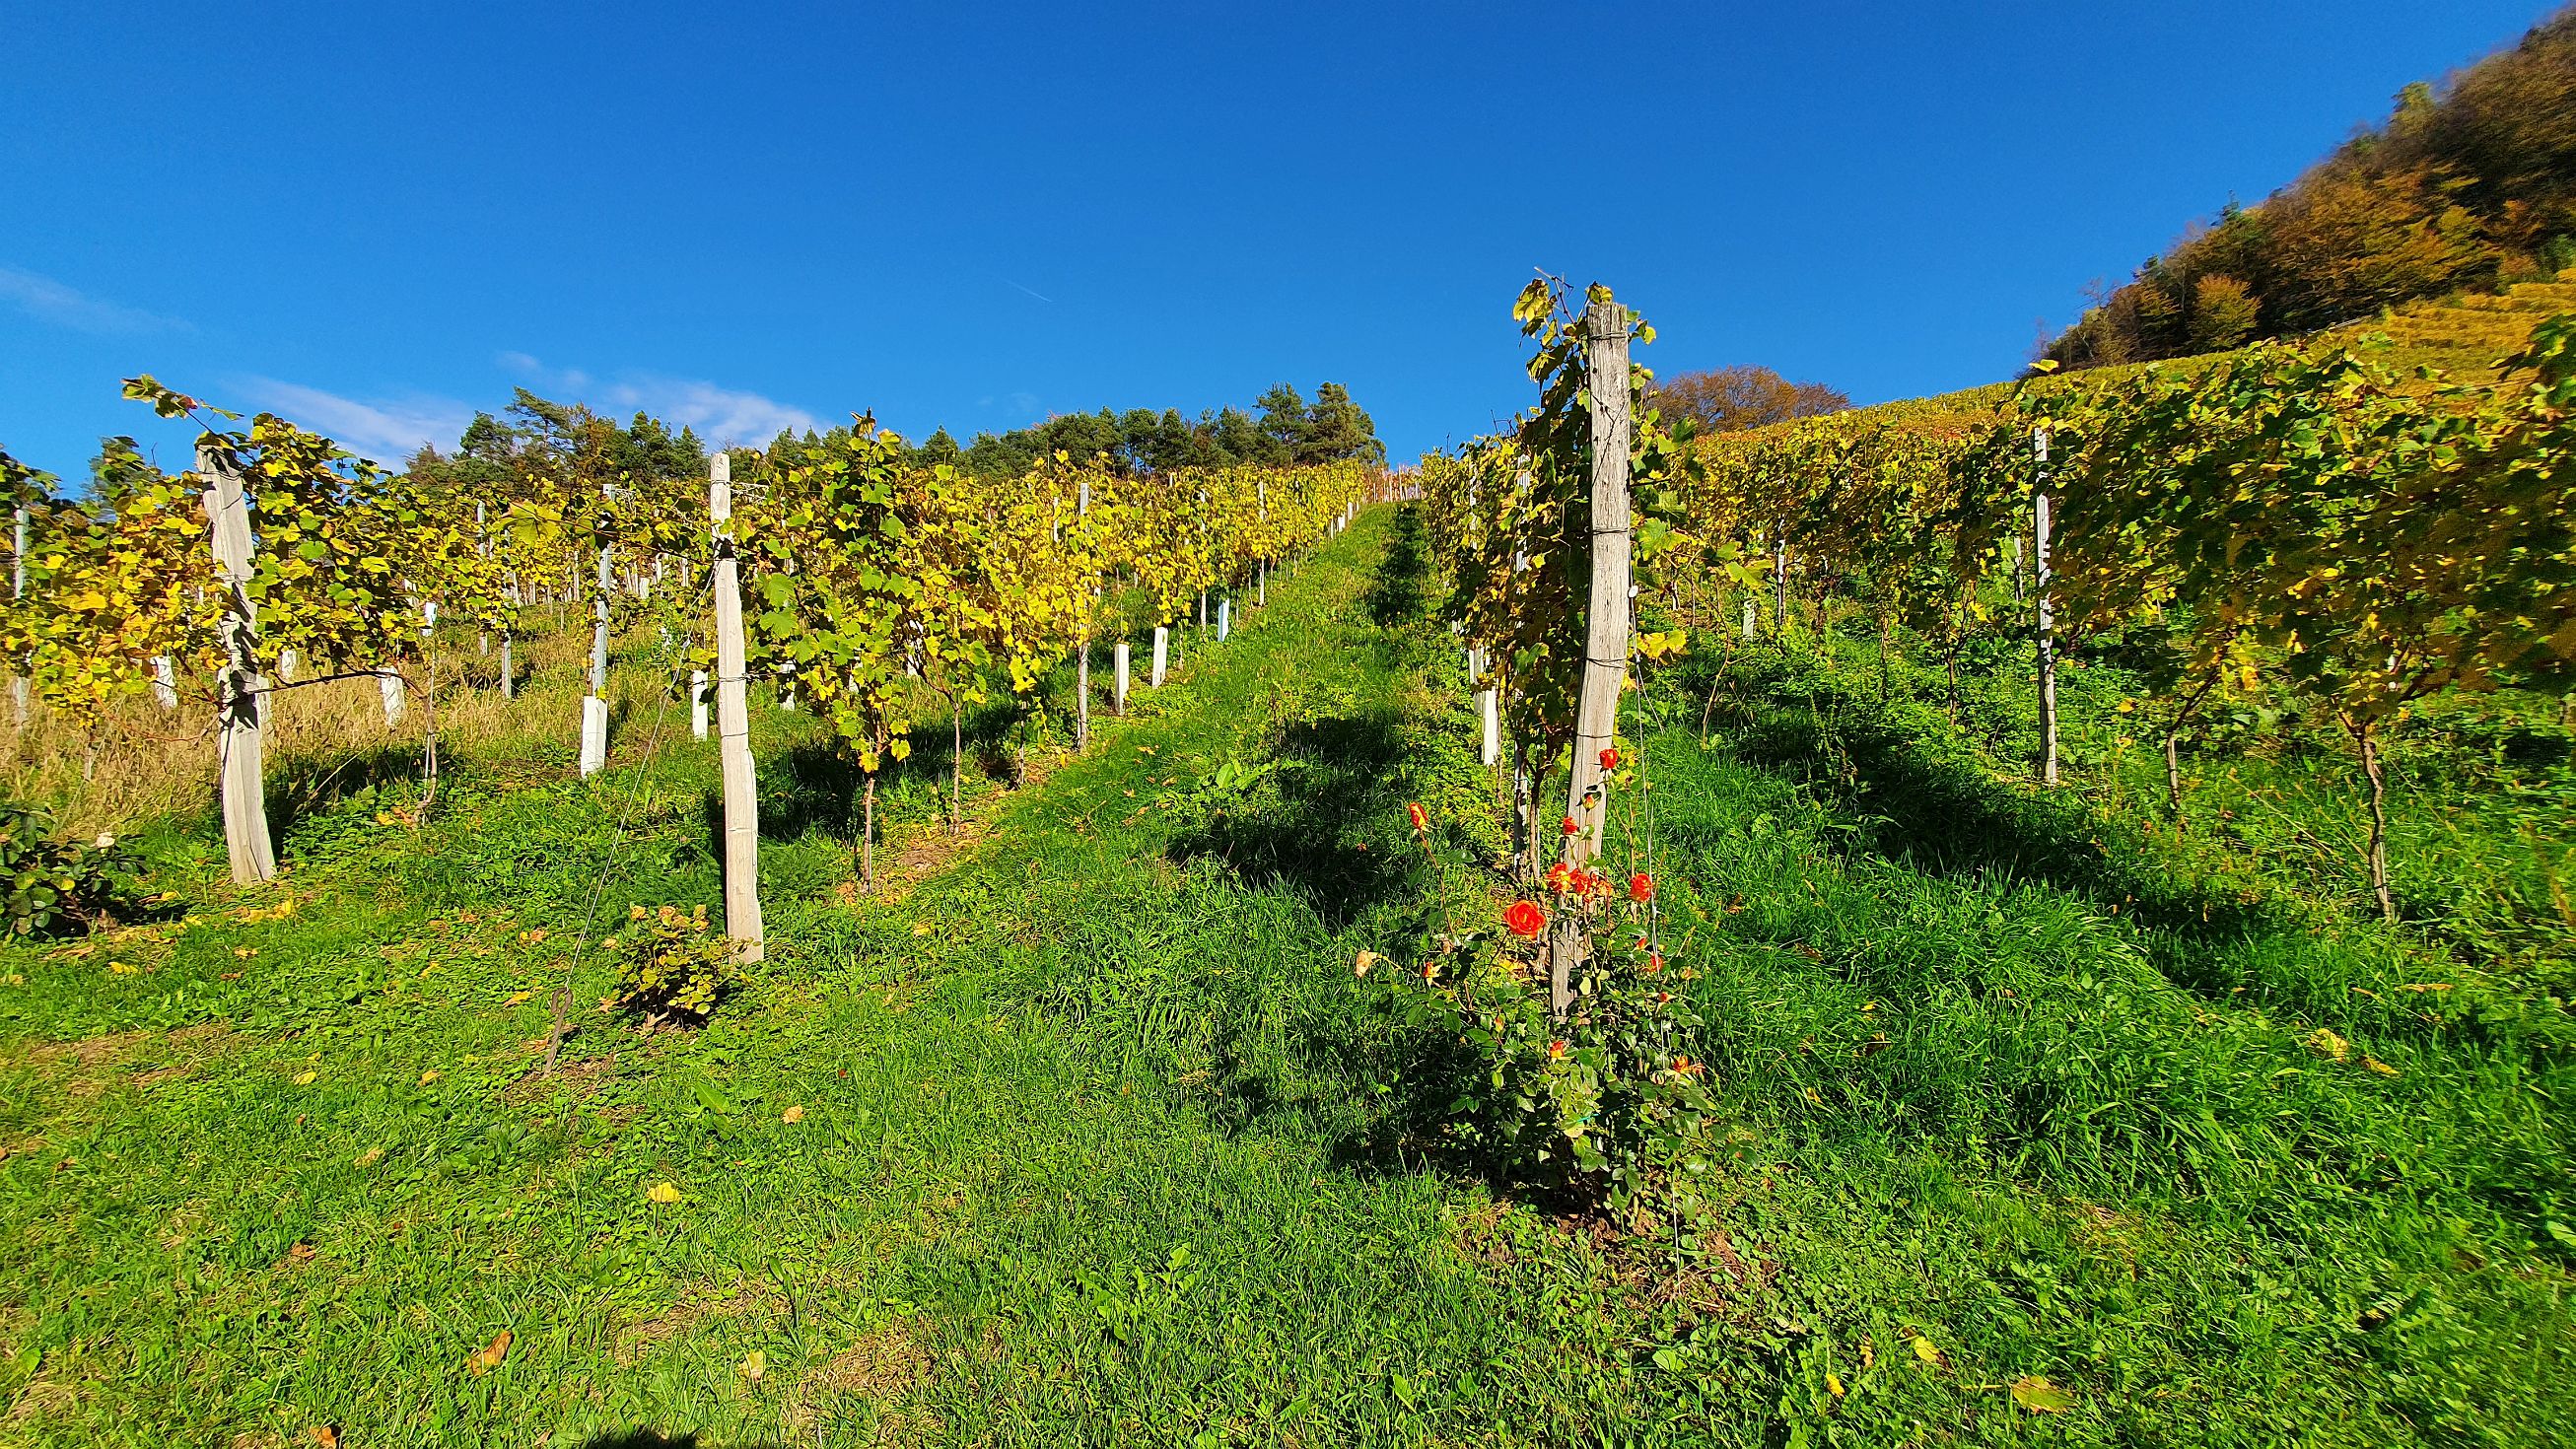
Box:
0;0;2542;476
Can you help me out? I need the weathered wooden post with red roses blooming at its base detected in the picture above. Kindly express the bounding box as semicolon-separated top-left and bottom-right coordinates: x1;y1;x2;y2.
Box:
1548;301;1634;1022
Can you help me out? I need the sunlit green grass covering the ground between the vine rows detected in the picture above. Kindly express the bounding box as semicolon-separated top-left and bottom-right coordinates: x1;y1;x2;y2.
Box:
0;510;2576;1446
